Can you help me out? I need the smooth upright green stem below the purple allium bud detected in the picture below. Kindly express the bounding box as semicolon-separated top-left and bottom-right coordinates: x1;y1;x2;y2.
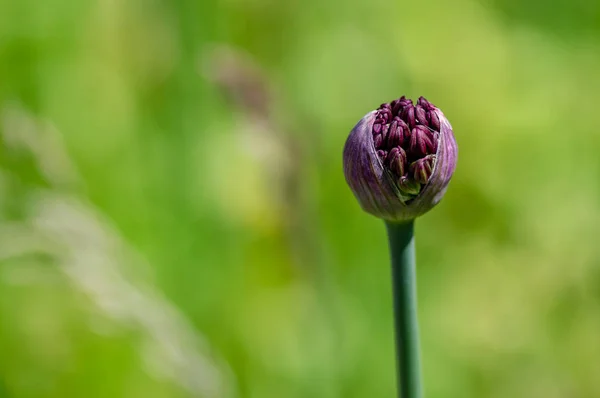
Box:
386;221;423;398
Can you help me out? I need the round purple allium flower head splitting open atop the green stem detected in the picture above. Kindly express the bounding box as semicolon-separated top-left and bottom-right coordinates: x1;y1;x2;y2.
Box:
344;97;458;222
